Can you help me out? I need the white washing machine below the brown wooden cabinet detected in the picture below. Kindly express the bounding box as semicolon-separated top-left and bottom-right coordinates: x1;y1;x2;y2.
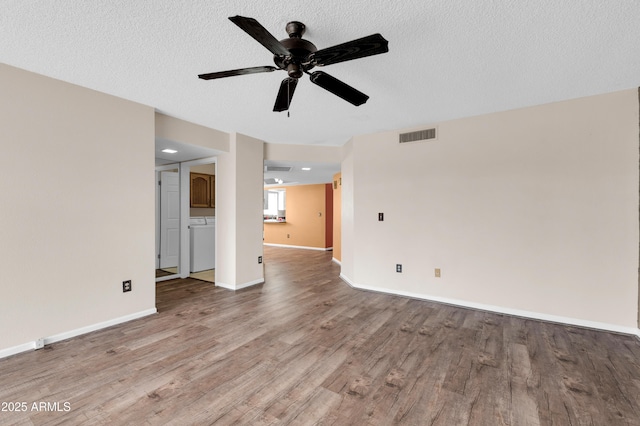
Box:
189;216;216;272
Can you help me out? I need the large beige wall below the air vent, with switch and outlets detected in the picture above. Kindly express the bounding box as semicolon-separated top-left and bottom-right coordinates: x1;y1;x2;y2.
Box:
342;90;639;331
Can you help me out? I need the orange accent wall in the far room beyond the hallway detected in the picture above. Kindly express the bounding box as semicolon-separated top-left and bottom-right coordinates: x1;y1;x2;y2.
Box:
264;184;333;248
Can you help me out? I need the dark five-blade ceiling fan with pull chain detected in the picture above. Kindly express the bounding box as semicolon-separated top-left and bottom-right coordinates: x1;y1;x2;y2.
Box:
198;16;389;111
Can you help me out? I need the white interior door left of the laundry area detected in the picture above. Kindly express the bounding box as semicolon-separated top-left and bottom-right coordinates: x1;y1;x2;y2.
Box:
160;172;180;268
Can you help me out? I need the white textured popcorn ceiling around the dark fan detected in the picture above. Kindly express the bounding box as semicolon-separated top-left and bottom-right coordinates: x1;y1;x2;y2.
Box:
0;0;640;145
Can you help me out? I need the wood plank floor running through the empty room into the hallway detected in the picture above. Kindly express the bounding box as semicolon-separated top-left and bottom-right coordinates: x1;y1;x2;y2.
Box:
0;247;640;426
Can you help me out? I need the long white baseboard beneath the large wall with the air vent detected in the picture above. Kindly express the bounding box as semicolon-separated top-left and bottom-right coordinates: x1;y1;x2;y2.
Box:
340;274;640;338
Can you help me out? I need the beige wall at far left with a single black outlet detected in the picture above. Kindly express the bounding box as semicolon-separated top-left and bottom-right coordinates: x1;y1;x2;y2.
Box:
0;64;155;355
